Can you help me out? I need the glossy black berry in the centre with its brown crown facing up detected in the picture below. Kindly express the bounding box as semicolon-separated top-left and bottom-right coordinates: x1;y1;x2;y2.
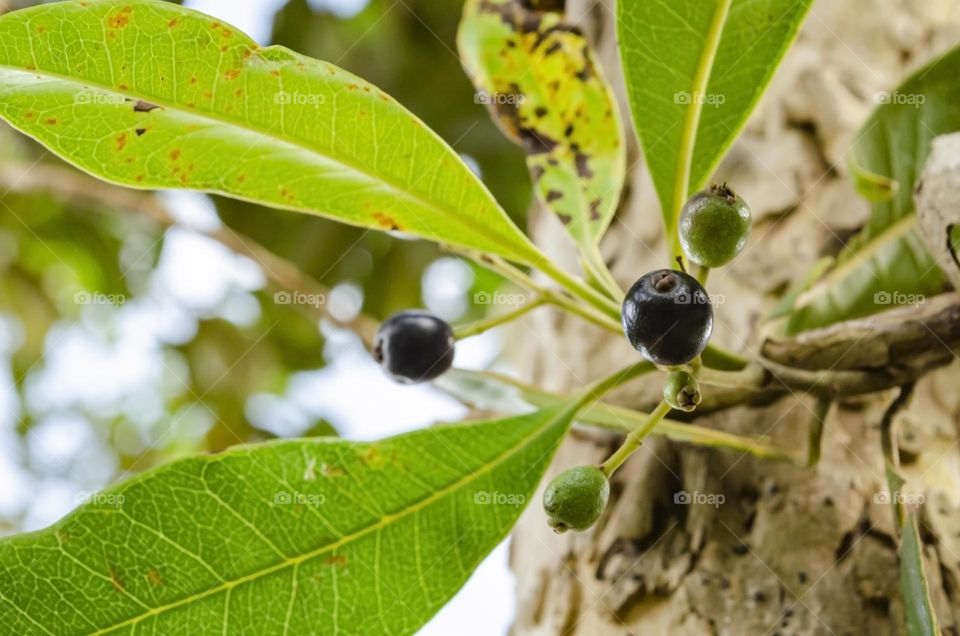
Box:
621;269;713;366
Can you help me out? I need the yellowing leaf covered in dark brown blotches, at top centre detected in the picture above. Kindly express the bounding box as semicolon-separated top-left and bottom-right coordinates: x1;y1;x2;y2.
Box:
457;0;626;252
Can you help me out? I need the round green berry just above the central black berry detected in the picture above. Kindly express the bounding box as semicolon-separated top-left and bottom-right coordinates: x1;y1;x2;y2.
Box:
680;184;750;267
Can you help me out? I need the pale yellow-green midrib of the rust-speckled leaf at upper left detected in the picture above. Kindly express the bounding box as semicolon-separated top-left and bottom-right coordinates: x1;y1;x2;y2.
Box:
0;60;539;265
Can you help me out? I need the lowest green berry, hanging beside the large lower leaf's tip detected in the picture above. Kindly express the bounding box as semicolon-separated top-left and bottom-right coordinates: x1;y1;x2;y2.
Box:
543;466;610;533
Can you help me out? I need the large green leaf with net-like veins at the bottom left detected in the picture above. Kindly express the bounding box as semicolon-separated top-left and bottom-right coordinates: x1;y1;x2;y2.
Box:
0;404;573;635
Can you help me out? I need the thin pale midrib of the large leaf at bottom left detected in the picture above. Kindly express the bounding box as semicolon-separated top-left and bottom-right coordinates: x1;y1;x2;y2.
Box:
79;404;576;636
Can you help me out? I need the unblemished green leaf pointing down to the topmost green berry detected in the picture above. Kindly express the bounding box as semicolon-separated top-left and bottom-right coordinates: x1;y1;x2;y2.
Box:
617;0;812;243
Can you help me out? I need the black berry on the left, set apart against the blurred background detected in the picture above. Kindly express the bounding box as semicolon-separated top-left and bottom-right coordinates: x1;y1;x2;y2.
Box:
373;311;456;384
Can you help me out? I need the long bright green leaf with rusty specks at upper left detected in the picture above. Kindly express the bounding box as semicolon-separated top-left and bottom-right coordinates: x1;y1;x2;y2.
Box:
0;0;544;265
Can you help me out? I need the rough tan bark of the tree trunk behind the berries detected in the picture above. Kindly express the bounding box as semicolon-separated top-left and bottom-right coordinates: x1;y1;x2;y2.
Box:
512;0;960;636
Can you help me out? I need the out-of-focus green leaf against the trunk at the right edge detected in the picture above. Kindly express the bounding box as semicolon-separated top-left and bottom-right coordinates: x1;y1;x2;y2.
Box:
787;48;960;333
